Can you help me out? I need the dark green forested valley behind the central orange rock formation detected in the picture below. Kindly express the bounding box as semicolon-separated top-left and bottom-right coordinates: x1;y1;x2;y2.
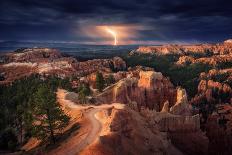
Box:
124;54;212;97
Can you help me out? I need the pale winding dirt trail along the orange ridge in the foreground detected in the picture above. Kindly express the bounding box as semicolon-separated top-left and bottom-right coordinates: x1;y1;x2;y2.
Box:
49;89;124;155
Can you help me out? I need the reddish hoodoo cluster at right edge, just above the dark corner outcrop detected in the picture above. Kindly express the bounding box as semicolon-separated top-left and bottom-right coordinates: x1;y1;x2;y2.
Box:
191;69;232;105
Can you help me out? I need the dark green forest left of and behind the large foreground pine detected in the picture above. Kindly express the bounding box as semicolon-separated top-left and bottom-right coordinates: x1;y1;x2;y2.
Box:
0;75;71;149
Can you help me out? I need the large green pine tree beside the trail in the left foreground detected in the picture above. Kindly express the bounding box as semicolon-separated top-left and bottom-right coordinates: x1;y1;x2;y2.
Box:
33;85;69;143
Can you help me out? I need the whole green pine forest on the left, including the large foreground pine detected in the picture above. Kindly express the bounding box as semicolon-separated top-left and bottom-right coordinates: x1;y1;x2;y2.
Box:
0;75;71;150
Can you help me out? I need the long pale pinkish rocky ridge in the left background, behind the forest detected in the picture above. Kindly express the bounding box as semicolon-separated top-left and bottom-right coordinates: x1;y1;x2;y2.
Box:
0;48;126;83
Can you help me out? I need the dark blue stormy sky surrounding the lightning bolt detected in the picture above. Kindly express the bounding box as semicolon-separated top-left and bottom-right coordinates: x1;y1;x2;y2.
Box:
0;0;232;44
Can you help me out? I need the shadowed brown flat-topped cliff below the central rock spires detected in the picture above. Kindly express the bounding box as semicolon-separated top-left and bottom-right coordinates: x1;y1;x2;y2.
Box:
141;109;209;155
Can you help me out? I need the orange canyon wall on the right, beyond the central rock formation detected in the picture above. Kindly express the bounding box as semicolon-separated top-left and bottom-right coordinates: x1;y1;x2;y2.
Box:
130;39;232;154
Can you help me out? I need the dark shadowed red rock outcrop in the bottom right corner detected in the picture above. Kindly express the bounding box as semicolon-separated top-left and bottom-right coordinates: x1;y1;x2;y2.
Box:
205;104;232;154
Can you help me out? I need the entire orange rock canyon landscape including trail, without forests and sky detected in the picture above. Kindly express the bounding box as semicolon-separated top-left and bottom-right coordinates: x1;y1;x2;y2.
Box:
0;40;232;155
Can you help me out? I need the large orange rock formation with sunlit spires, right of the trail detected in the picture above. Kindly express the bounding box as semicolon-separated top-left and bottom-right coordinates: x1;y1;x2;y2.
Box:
93;70;209;154
